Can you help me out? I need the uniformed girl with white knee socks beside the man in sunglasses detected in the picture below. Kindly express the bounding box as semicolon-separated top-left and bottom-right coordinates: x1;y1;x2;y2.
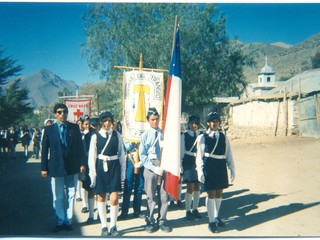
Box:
89;112;126;236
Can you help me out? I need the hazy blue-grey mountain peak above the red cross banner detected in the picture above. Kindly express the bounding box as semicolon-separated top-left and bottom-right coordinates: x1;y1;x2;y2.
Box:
21;69;79;108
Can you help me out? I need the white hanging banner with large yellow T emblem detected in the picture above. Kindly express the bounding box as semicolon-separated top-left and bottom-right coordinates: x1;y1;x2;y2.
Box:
122;70;163;142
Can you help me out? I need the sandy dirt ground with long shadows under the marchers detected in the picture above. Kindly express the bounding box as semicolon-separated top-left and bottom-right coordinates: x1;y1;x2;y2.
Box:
0;136;320;238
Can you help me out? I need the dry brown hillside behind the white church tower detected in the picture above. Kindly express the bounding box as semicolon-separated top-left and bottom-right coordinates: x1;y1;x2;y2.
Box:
240;33;320;83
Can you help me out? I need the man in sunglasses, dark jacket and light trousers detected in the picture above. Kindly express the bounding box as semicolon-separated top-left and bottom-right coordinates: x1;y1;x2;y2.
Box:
41;103;85;232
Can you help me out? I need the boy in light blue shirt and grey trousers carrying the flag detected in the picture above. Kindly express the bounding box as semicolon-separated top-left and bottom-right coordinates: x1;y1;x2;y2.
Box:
139;108;172;233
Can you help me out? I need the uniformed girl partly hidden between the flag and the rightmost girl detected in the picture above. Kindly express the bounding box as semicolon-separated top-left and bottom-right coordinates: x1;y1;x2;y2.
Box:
181;115;201;220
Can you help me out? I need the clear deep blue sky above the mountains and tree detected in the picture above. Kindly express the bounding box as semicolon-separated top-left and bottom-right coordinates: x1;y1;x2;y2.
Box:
0;1;320;85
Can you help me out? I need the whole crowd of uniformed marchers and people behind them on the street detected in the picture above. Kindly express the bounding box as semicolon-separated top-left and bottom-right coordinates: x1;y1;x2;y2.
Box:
1;103;235;237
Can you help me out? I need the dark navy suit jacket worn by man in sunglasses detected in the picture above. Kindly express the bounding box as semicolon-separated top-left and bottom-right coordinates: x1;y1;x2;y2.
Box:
41;122;85;177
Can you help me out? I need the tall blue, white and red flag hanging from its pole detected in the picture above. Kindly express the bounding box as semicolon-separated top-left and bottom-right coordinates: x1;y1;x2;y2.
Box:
161;25;182;200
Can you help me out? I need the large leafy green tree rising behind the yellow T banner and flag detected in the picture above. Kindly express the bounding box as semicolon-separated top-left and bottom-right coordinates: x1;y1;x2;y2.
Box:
82;3;249;111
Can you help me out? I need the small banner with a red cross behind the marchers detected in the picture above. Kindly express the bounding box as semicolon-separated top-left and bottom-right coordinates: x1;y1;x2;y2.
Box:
64;99;92;123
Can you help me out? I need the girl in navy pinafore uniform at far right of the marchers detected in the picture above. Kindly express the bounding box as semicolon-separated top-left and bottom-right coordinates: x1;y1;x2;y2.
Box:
196;112;235;233
